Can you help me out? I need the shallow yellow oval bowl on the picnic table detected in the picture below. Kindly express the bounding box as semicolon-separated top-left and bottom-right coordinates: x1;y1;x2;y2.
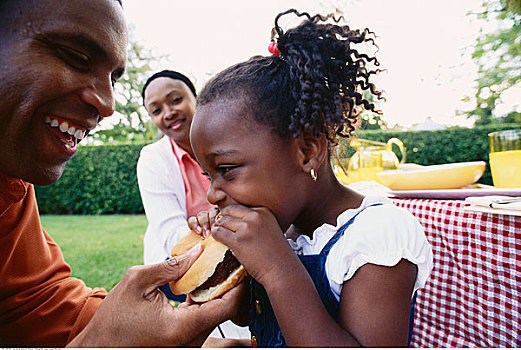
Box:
376;161;486;191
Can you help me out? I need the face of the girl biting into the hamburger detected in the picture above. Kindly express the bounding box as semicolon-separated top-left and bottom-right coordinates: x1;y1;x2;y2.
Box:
191;100;309;230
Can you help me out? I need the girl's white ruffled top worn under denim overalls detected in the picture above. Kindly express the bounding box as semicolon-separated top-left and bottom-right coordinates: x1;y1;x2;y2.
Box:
288;196;433;300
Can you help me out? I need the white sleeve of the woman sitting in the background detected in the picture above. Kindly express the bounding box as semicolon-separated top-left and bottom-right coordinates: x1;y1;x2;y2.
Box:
137;141;188;264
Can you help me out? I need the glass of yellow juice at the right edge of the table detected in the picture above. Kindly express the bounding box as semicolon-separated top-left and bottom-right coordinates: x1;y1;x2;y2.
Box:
488;130;521;188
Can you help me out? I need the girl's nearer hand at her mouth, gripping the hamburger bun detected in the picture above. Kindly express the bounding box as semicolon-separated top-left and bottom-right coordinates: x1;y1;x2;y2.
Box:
207;204;300;287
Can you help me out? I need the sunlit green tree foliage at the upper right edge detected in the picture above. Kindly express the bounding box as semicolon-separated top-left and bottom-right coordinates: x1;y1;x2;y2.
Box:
466;0;521;125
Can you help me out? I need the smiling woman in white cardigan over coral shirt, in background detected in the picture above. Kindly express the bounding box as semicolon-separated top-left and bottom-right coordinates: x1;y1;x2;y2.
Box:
137;70;212;265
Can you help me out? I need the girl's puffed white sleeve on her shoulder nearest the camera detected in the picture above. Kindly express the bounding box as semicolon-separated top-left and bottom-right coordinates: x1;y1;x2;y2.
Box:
326;204;433;297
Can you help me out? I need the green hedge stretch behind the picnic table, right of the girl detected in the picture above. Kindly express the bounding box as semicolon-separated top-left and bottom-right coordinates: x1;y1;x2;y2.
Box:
338;124;521;185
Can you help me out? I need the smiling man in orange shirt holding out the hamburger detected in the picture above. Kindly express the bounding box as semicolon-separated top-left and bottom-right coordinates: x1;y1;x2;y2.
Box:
0;0;237;347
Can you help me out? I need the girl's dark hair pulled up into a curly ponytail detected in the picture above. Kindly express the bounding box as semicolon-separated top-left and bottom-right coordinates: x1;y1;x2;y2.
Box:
197;9;383;141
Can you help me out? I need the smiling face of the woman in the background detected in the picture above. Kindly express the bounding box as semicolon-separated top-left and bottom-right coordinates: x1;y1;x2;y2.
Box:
144;77;195;149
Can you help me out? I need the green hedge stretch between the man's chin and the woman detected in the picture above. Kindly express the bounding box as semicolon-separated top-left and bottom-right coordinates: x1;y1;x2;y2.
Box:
36;144;144;214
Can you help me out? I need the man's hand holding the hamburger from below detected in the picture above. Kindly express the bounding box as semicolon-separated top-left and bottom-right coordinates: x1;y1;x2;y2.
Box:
68;245;245;348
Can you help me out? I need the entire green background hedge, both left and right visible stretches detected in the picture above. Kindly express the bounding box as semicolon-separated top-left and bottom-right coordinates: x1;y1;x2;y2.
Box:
36;124;521;214
